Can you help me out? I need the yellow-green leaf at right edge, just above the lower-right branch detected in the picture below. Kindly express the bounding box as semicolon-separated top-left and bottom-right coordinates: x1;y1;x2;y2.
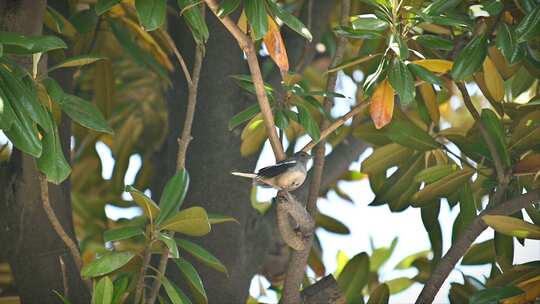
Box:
482;215;540;240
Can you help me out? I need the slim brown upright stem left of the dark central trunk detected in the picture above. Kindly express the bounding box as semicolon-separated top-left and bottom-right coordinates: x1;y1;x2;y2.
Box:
148;22;205;304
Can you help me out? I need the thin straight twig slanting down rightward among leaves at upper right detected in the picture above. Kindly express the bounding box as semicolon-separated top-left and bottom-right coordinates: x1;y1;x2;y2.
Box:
456;81;508;184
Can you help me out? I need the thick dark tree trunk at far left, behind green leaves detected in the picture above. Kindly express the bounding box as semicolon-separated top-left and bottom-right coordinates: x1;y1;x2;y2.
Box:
0;0;90;303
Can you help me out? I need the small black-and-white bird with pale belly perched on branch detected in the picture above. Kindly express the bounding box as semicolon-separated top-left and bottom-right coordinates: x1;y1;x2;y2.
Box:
231;151;312;191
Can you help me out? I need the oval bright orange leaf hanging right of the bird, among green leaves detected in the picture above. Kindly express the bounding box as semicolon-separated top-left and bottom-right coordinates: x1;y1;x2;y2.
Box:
369;79;394;129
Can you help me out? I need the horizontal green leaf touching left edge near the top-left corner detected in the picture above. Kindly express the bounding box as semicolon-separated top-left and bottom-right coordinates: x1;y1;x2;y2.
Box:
0;32;67;55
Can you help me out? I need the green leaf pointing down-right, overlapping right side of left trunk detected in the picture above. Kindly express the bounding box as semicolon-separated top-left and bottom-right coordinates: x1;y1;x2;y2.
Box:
58;94;114;134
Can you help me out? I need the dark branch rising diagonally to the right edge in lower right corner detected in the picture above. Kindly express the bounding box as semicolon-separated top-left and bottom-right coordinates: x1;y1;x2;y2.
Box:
416;189;540;304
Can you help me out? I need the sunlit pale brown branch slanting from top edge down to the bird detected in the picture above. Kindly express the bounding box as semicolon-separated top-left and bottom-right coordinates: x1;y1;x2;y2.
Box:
205;0;286;161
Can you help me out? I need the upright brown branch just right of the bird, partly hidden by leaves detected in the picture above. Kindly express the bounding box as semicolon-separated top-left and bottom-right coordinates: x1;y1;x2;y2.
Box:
282;0;351;304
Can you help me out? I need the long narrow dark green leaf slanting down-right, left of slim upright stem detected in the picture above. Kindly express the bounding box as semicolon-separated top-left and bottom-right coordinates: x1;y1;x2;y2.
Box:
111;21;169;81
